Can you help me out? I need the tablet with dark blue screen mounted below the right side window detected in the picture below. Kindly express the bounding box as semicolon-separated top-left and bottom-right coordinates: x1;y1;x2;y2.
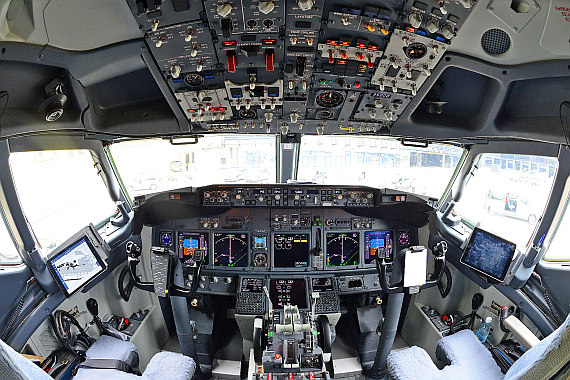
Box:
461;228;516;281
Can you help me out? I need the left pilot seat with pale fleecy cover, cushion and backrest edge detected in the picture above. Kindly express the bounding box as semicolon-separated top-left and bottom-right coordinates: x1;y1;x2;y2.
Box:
0;335;196;380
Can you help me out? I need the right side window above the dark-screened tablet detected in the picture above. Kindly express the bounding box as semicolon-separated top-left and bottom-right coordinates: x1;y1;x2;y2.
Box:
454;153;558;252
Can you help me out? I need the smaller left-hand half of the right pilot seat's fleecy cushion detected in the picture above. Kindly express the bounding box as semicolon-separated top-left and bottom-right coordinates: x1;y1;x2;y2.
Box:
388;346;441;380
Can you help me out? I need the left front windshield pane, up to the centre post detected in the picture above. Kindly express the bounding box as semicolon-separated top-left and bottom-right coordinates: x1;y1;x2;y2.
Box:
110;135;276;197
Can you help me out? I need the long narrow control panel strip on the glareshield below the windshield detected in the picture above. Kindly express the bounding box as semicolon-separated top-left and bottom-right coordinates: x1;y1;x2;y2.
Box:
201;186;377;206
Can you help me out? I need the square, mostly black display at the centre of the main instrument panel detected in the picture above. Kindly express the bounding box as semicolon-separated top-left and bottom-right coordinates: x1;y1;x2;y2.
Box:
273;234;310;268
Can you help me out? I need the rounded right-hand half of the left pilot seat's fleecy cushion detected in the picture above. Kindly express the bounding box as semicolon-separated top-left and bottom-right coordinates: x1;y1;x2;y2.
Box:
143;351;196;380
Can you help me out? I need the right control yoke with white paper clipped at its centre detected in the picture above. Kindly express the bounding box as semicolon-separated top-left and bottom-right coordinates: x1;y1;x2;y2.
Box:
376;240;447;293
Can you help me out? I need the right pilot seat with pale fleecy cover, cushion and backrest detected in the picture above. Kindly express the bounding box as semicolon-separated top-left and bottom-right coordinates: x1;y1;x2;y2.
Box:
388;314;570;380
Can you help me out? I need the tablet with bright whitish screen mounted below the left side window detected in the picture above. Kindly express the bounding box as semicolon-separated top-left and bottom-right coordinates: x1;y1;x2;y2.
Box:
48;237;105;297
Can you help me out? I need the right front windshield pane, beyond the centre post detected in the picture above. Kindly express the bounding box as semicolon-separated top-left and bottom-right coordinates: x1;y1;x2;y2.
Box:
297;136;463;199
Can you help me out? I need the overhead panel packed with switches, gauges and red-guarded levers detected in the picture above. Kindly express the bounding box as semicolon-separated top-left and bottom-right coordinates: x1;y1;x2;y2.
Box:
125;0;475;134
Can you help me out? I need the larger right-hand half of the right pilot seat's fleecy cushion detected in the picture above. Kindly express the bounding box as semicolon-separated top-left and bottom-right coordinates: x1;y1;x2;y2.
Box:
437;330;504;380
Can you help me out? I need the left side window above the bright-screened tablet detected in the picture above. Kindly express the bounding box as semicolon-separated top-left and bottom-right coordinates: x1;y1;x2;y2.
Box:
10;149;116;256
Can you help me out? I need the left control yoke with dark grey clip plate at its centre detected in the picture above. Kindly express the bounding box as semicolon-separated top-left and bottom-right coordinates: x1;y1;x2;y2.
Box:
126;241;202;297
